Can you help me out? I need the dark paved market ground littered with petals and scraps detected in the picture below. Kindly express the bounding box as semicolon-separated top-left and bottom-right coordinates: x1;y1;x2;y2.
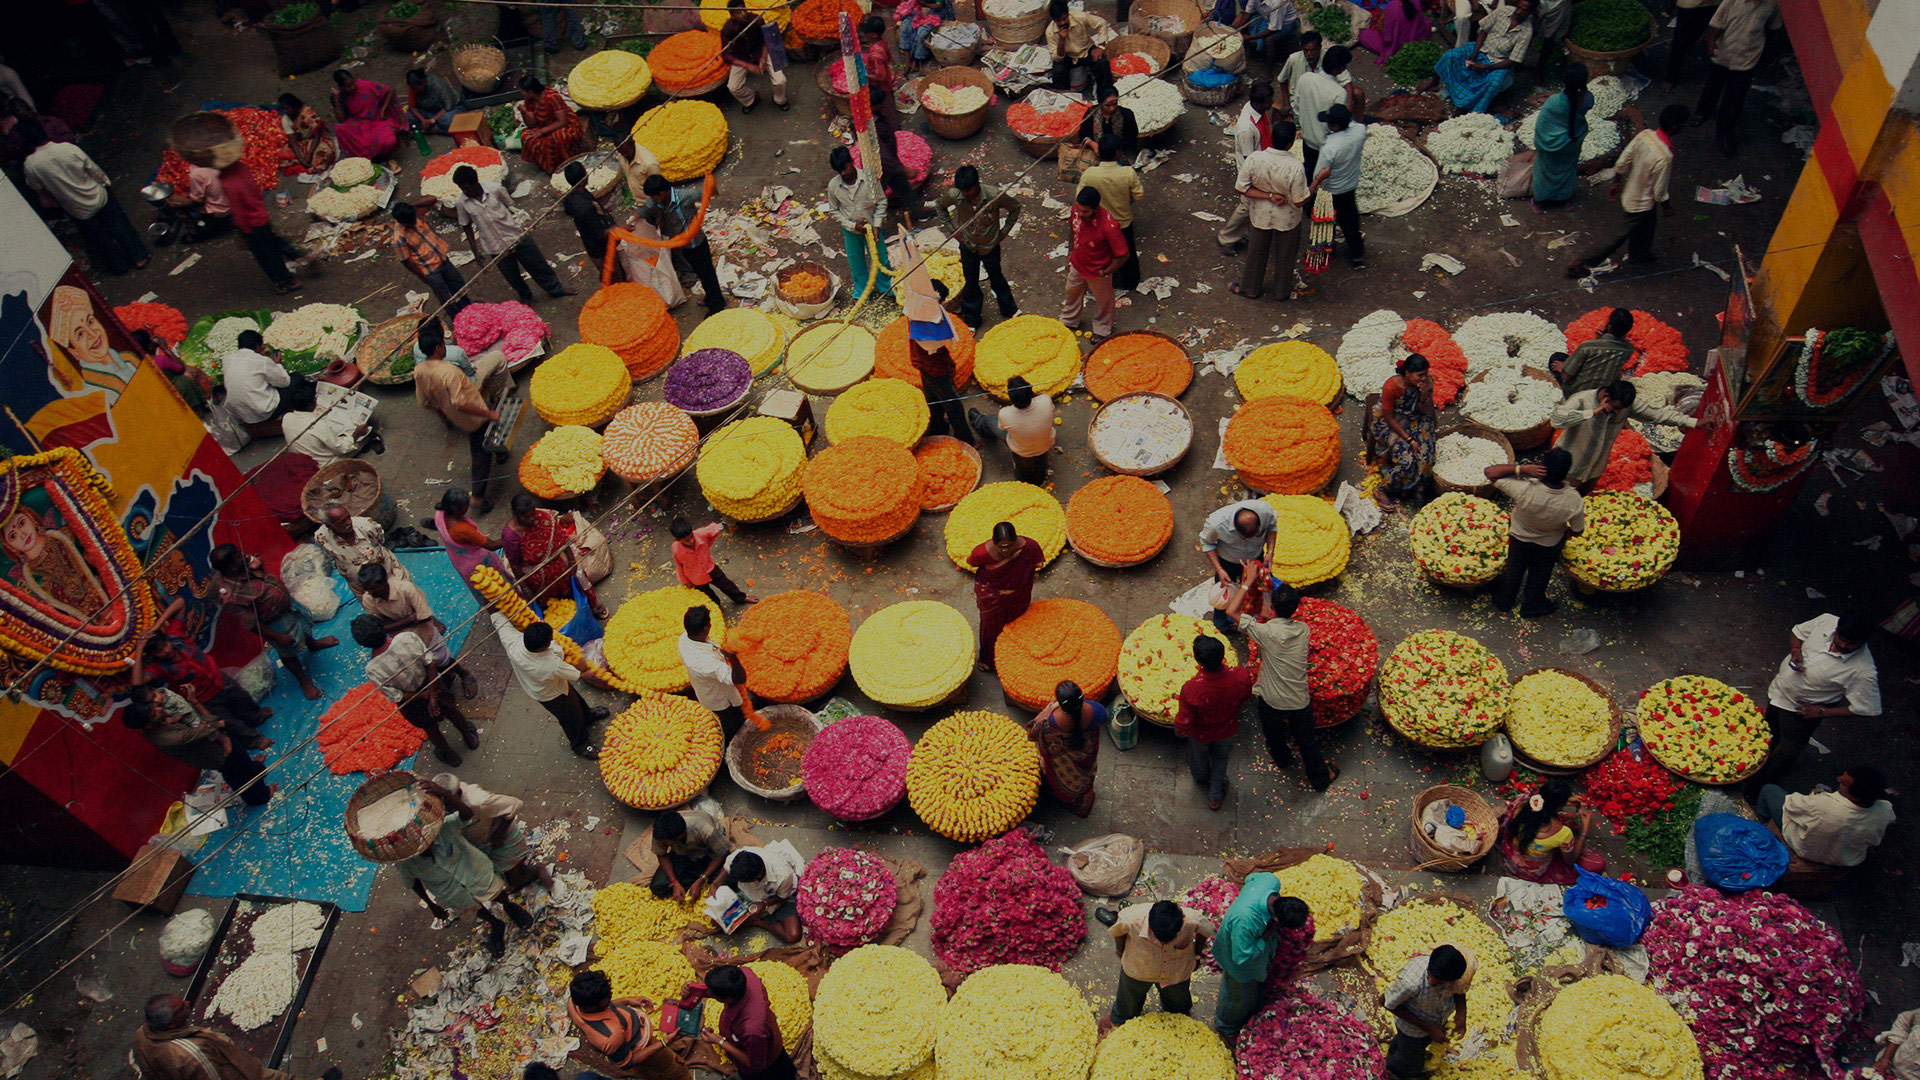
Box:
0;8;1920;1078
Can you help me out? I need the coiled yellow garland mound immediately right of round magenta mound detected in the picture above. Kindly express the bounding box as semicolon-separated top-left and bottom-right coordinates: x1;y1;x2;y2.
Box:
906;711;1041;844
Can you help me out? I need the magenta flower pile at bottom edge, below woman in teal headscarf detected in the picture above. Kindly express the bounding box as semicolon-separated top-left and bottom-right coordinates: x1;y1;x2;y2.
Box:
1233;986;1386;1080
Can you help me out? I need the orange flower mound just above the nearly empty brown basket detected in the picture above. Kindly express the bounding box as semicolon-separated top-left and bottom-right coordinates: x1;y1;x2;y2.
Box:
728;590;852;705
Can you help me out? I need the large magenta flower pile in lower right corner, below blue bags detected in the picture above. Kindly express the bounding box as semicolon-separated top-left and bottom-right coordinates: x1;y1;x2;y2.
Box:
1642;886;1866;1080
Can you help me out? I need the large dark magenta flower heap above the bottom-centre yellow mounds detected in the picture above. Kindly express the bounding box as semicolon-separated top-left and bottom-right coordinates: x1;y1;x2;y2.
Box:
933;826;1087;974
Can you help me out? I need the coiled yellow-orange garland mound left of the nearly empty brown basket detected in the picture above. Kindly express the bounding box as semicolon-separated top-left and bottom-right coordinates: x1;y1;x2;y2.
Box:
601;694;720;809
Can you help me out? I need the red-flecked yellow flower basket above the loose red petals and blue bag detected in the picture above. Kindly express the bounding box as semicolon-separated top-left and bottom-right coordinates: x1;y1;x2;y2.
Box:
1634;675;1772;784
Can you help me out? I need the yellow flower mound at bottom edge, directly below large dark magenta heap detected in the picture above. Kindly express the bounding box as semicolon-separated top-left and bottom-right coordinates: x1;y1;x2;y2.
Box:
933;965;1098;1080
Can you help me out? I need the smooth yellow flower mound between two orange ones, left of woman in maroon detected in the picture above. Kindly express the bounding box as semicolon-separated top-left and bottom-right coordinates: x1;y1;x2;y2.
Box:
847;600;973;709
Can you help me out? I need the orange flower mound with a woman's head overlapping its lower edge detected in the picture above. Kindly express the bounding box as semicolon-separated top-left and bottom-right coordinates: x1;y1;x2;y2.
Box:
993;598;1119;709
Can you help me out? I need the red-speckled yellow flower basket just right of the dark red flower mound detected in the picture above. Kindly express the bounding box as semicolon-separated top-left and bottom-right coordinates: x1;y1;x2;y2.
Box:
1380;630;1513;748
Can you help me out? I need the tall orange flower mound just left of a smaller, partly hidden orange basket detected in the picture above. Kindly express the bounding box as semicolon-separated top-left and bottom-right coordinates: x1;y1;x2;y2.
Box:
801;434;922;544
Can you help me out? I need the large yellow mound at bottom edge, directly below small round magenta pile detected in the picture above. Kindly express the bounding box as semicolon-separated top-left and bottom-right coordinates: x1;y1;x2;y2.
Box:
814;945;947;1078
